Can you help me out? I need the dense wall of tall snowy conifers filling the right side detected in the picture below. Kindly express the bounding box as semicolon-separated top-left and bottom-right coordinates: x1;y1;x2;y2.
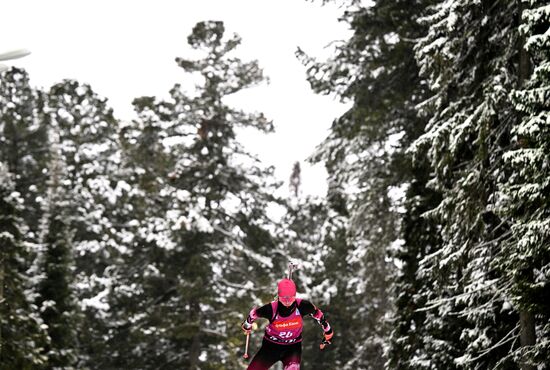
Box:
298;0;550;369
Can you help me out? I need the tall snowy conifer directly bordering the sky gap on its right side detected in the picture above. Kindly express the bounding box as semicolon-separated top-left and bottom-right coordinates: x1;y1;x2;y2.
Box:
299;0;436;369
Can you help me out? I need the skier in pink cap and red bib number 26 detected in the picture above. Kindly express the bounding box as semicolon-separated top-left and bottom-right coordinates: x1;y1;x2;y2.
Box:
241;279;334;370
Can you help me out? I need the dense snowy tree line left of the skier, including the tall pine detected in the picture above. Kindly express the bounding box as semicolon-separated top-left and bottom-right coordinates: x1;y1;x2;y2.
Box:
0;22;288;370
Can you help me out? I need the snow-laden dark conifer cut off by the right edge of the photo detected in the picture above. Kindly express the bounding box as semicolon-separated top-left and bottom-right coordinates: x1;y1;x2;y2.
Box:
496;1;550;370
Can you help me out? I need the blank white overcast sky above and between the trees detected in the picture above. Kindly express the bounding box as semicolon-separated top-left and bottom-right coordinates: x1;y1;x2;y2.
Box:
0;0;349;195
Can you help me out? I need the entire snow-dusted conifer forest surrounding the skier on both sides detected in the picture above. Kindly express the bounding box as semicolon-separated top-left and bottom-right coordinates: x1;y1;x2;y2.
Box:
0;0;550;370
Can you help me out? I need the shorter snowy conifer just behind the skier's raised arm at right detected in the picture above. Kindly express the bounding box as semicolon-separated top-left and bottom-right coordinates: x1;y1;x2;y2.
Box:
288;197;362;369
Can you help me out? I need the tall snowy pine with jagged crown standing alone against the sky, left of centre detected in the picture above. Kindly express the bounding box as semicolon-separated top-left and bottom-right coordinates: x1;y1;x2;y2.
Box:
172;22;281;368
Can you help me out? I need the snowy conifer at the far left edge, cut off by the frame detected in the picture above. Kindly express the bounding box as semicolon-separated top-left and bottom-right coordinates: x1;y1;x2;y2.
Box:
0;68;48;369
